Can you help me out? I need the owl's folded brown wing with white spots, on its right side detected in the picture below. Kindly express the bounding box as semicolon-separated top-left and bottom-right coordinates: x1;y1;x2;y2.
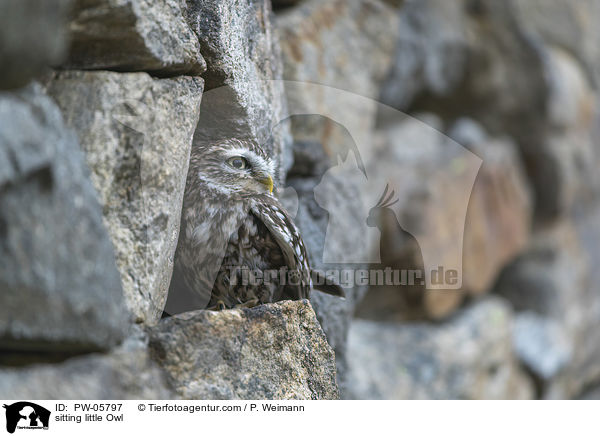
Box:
251;196;345;298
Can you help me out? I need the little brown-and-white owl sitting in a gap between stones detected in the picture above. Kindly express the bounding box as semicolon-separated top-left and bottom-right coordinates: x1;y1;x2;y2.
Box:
169;139;344;310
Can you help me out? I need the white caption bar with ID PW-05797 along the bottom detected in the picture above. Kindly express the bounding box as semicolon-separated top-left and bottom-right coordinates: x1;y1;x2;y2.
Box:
0;400;600;436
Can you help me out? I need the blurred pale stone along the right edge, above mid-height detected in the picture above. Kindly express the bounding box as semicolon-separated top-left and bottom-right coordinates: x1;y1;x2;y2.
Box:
526;47;600;220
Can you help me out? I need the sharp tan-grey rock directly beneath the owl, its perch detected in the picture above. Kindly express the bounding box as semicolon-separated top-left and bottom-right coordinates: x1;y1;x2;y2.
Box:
149;301;338;400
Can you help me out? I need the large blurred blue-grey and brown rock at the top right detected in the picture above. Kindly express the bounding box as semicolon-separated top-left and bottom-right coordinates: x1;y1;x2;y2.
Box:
382;0;548;138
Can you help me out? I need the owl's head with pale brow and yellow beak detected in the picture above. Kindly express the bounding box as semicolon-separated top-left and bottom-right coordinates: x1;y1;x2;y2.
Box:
190;139;275;195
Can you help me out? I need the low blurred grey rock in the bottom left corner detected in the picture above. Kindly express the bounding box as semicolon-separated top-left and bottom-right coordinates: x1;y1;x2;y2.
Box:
0;334;173;400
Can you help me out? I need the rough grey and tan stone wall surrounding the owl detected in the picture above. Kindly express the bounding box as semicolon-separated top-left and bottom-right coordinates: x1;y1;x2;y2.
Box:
0;0;600;399
